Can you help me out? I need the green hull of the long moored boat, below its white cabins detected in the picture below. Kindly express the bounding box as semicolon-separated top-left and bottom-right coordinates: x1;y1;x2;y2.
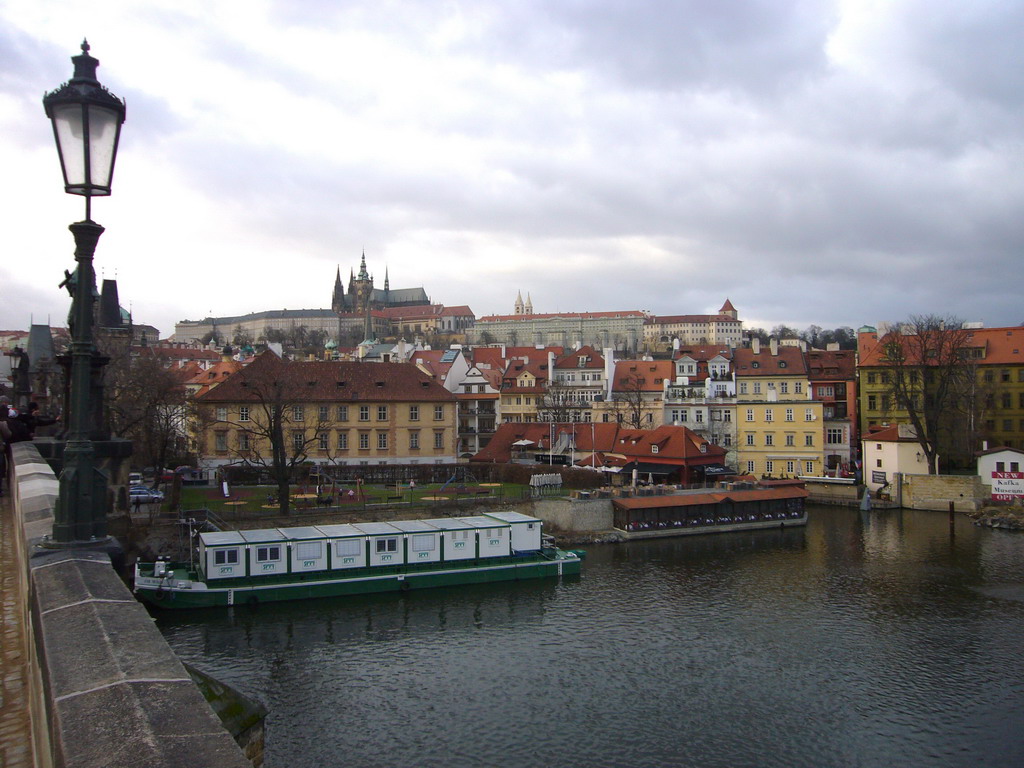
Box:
135;550;582;609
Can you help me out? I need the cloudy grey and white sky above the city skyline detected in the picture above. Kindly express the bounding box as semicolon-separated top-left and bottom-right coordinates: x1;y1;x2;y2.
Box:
0;0;1024;335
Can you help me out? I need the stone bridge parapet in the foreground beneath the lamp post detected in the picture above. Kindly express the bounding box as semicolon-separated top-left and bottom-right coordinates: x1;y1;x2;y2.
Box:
11;443;251;768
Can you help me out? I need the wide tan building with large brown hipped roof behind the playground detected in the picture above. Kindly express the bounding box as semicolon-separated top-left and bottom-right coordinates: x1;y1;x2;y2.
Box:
196;352;458;468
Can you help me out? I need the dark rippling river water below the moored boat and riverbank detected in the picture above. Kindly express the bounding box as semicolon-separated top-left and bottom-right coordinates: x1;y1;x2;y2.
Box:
158;507;1024;768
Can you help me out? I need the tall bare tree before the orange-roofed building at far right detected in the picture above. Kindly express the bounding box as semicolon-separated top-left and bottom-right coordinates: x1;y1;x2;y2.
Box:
881;314;978;474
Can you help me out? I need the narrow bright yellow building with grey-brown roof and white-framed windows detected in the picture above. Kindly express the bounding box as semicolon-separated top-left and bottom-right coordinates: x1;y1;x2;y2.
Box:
734;339;824;477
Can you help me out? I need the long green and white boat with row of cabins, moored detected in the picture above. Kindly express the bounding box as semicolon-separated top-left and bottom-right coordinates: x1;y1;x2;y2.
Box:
135;512;583;608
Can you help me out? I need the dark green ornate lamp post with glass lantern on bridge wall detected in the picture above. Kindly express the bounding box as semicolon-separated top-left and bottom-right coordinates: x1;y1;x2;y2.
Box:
43;41;125;548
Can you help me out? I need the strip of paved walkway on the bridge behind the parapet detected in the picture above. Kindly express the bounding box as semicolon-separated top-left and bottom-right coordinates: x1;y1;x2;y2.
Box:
0;493;35;768
